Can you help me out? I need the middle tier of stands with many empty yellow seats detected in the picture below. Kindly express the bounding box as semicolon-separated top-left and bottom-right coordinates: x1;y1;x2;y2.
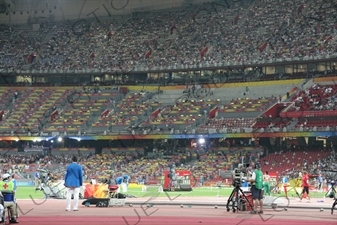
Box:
0;79;336;136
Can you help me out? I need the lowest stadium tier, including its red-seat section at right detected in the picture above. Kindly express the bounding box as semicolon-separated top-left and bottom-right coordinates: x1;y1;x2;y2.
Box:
2;145;335;187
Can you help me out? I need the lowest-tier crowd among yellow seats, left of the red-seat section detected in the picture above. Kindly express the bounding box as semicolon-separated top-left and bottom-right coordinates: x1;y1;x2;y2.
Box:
1;148;255;185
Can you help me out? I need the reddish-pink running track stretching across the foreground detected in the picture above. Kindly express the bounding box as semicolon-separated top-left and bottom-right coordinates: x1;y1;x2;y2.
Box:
15;199;337;225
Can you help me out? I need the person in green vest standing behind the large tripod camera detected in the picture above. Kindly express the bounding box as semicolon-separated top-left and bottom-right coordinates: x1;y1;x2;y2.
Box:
250;164;263;214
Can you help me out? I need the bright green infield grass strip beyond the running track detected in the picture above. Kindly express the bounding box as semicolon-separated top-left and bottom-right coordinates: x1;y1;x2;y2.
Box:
15;186;325;199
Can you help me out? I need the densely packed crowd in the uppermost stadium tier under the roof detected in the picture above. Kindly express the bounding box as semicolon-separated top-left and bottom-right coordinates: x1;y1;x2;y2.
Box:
0;0;337;71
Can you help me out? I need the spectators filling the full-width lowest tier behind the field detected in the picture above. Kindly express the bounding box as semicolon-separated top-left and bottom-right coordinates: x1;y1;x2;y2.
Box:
0;144;337;188
